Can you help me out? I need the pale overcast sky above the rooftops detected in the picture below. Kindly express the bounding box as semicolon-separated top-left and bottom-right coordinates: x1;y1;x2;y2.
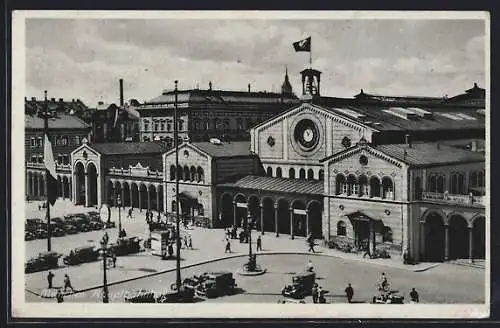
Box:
26;18;485;106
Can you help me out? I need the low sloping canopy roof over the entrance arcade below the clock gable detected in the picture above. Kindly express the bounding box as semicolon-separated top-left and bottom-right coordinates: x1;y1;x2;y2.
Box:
219;175;324;195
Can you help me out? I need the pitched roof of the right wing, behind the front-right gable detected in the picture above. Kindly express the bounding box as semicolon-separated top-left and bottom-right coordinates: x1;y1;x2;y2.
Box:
373;142;485;166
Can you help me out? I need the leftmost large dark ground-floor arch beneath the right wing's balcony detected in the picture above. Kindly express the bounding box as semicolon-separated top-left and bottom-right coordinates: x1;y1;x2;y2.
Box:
425;213;445;262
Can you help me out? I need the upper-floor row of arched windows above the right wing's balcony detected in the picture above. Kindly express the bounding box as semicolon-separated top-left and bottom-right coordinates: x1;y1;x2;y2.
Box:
415;170;486;195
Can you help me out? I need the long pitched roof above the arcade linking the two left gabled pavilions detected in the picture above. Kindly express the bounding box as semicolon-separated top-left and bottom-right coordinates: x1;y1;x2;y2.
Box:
89;142;169;155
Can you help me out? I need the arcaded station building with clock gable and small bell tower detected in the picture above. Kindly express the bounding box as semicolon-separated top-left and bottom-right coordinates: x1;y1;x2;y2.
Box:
62;69;486;261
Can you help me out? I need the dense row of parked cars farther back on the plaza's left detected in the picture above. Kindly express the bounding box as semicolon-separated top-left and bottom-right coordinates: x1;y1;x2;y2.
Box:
24;211;115;240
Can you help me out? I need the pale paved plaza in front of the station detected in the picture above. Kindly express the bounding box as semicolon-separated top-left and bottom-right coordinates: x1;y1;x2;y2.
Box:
25;201;485;303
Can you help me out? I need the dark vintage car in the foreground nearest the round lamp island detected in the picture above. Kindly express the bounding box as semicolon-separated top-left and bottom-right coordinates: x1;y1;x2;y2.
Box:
196;271;236;298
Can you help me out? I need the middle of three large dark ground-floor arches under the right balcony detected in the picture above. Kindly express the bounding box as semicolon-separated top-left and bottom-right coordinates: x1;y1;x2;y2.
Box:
448;215;469;260
